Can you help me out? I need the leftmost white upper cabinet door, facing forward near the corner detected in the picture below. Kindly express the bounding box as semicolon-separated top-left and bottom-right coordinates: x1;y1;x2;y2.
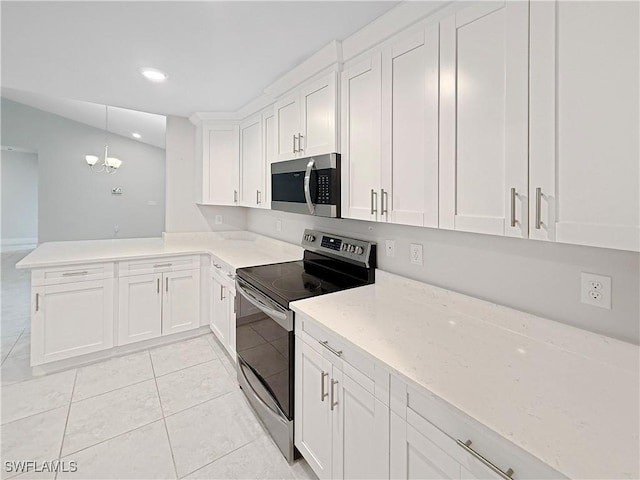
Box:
208;125;240;205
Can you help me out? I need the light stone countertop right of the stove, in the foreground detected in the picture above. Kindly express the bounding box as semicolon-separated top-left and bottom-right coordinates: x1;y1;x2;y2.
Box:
291;270;640;479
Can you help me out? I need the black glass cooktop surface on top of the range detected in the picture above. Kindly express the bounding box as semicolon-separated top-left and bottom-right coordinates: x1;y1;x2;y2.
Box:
237;252;370;308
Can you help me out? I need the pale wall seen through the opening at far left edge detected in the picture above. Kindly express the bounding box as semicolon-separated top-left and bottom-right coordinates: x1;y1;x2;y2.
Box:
0;150;38;247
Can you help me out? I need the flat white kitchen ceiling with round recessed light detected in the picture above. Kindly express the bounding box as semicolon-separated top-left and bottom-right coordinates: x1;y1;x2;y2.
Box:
1;1;398;116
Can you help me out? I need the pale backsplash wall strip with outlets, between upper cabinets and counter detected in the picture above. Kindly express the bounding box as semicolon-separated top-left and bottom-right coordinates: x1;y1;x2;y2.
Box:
247;209;640;344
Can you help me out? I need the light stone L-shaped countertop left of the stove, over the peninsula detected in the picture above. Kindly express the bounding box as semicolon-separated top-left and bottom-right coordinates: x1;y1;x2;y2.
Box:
16;231;303;269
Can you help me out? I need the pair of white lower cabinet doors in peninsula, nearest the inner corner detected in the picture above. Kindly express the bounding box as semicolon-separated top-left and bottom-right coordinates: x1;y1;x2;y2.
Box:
118;264;200;345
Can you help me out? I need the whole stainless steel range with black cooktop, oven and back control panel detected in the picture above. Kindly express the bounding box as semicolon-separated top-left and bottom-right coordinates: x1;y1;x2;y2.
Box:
236;230;376;462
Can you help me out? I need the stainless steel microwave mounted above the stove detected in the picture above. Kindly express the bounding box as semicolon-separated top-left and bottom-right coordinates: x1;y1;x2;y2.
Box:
271;153;340;218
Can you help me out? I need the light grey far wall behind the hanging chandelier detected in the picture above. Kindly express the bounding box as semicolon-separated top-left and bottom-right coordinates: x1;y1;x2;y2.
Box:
2;98;165;243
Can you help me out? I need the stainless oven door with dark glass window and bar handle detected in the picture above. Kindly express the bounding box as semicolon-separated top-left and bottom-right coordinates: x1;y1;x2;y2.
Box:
236;277;294;420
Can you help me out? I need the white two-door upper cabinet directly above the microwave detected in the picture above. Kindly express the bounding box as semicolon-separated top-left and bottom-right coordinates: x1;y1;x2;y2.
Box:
275;72;338;161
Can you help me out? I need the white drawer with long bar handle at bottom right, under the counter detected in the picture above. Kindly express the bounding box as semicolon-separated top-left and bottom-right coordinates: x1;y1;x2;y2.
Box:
406;387;565;480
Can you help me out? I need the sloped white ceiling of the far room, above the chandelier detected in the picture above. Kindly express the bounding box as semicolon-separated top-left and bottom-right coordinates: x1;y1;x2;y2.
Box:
2;87;166;148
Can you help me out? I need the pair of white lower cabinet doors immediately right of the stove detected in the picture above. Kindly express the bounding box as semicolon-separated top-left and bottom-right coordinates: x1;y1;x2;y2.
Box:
295;322;389;479
